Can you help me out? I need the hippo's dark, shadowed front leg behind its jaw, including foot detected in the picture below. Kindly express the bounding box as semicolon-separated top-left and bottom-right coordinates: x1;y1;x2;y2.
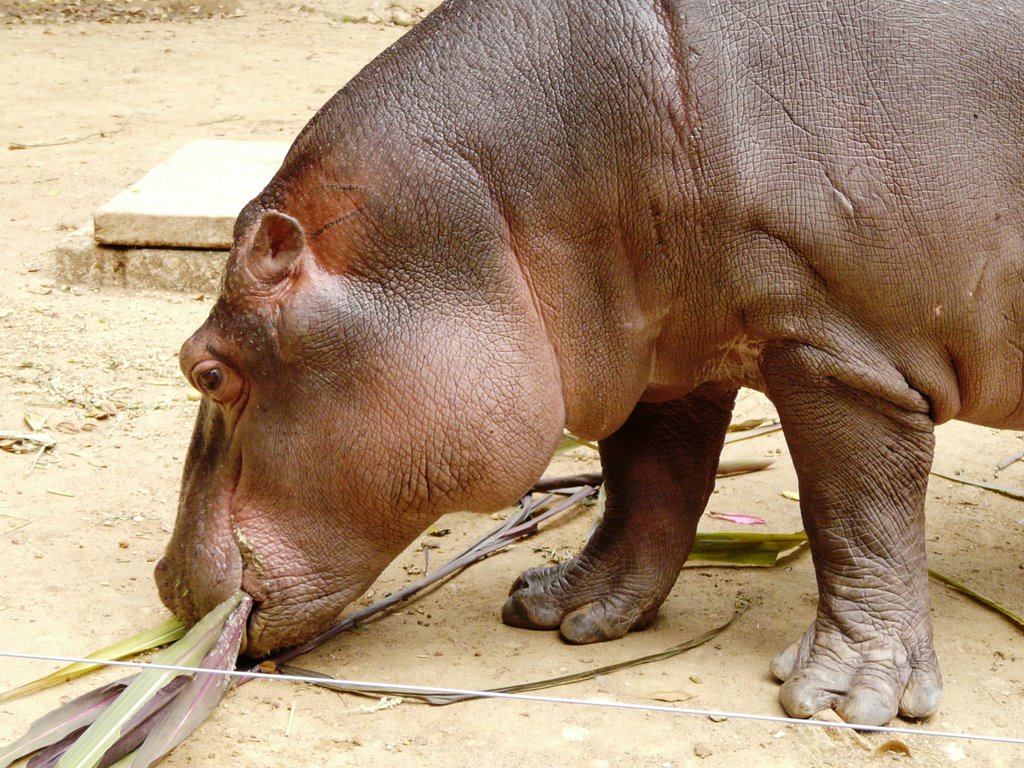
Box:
502;385;736;643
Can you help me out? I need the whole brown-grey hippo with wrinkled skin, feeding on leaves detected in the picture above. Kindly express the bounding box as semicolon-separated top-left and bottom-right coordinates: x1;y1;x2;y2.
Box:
157;0;1024;723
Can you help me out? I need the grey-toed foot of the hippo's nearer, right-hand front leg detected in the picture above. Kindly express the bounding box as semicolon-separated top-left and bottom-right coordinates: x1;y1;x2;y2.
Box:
771;620;942;725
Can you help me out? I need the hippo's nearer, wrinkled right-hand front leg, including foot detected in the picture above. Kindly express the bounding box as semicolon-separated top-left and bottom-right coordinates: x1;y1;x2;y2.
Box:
762;345;942;725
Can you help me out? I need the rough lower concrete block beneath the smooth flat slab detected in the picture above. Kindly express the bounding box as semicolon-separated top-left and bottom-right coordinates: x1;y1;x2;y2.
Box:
54;224;227;295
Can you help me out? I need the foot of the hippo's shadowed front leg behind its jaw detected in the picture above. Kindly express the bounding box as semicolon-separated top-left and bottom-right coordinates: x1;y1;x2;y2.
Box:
502;556;667;644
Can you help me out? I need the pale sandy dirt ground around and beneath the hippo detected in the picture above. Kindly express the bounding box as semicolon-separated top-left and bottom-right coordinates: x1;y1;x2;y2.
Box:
0;0;1024;768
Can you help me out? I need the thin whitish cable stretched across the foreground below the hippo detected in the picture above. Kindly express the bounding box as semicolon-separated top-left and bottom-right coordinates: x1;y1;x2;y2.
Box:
0;651;1024;745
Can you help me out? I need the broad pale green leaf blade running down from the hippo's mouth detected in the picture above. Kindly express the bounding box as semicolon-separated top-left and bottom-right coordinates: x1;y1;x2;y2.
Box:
57;591;246;768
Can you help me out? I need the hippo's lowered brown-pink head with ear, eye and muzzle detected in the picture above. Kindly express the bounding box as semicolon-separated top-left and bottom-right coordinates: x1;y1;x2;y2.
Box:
157;171;564;655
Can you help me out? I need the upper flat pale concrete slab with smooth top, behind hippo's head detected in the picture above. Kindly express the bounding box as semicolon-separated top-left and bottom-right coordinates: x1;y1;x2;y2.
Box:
93;139;289;248
